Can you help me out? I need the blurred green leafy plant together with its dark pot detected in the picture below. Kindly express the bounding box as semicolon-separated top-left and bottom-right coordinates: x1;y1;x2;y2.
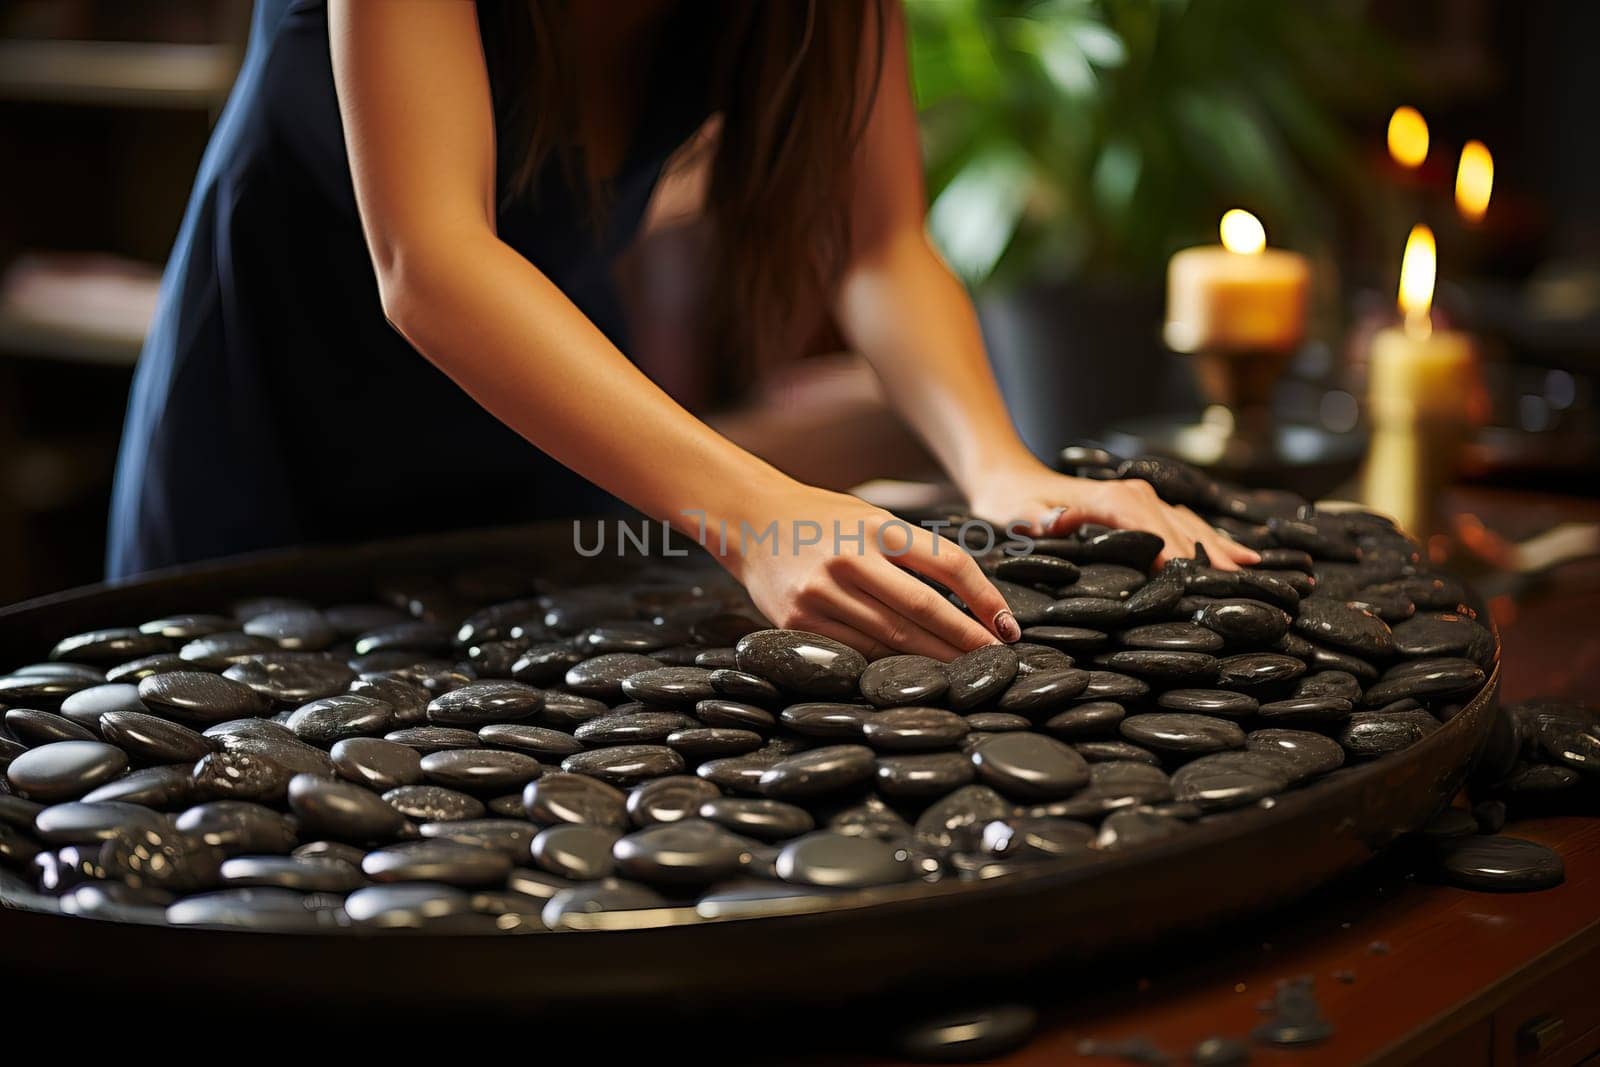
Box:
907;0;1392;458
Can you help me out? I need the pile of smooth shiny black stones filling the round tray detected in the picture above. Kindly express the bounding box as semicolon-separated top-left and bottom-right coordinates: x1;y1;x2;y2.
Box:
0;450;1496;933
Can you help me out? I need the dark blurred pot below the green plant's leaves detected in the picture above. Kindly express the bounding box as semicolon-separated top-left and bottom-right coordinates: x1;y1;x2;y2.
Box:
978;282;1198;462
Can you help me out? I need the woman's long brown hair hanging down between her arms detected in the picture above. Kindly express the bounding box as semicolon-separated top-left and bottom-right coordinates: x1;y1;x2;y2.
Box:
483;0;890;383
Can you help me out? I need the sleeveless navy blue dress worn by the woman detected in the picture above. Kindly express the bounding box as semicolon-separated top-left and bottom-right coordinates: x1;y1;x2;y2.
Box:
106;0;704;577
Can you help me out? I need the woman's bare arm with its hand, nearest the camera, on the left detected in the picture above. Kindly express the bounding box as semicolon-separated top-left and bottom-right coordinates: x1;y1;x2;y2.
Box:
330;0;1014;657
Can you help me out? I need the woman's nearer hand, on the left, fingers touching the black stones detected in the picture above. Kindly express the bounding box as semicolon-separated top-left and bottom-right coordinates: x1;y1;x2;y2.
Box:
710;482;1022;661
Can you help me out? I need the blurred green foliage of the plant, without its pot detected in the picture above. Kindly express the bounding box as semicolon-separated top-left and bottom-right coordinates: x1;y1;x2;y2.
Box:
906;0;1398;285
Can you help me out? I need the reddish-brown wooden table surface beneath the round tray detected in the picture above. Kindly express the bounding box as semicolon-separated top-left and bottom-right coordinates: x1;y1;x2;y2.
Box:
864;491;1600;1067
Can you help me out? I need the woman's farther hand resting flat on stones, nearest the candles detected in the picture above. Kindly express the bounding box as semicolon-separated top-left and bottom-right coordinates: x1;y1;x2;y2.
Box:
970;461;1261;571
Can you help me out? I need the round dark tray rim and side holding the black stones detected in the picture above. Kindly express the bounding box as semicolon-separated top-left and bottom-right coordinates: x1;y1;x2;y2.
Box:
0;523;1499;1014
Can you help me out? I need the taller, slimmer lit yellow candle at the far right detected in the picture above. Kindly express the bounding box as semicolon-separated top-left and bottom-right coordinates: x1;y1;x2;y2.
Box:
1363;226;1477;541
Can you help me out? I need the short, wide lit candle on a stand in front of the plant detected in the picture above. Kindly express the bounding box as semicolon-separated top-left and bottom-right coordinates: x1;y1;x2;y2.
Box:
1165;208;1310;352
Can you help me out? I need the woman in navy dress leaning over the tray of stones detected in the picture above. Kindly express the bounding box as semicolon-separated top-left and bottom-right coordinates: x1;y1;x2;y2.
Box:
109;0;1254;659
